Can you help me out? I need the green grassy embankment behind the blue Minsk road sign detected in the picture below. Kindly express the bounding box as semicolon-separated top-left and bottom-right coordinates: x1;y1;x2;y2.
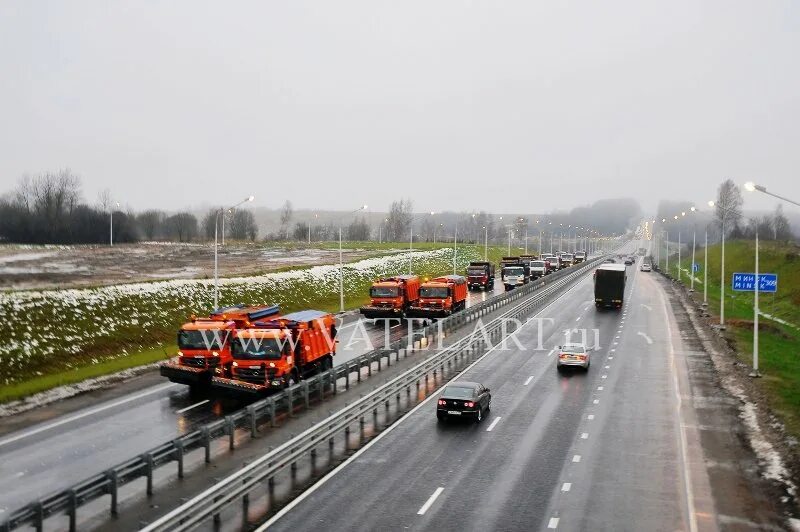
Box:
661;241;800;439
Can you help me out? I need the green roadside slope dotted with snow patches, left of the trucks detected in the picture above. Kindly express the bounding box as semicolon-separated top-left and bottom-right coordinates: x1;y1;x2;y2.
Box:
0;242;506;402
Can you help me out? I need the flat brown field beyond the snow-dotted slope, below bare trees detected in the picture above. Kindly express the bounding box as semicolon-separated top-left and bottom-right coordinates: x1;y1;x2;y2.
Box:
0;242;380;290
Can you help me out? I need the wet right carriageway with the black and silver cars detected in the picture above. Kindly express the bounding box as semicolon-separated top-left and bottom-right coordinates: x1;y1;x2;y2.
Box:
262;249;715;531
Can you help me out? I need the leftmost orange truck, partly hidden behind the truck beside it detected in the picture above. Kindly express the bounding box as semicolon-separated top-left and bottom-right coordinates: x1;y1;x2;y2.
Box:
160;305;280;386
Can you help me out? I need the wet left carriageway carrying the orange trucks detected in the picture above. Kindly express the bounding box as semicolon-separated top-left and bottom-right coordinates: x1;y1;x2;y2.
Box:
0;281;503;519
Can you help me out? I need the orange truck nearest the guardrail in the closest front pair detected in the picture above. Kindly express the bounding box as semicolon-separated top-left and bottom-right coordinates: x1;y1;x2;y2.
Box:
211;310;336;394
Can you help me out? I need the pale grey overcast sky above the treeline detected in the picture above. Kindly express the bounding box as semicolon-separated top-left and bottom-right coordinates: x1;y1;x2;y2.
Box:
0;0;800;212
